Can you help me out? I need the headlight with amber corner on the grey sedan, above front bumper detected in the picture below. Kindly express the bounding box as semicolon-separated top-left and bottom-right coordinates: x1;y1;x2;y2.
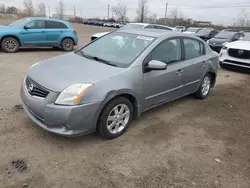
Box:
55;83;93;105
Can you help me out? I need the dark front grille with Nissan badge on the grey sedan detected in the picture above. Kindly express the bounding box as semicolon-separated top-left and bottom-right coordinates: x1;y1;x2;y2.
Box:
25;77;49;98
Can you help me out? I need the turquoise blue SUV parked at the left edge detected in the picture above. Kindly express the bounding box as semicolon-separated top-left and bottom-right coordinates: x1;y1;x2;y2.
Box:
0;18;78;52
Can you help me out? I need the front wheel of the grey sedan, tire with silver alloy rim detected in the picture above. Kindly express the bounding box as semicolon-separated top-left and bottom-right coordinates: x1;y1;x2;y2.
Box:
98;97;134;139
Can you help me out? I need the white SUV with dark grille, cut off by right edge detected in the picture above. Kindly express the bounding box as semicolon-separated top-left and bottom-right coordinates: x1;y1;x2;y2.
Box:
220;32;250;71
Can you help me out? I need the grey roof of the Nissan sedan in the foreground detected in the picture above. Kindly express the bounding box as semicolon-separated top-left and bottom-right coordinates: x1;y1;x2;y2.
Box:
115;28;196;38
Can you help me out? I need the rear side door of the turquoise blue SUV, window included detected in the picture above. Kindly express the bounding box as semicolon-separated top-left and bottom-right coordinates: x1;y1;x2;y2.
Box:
45;21;68;45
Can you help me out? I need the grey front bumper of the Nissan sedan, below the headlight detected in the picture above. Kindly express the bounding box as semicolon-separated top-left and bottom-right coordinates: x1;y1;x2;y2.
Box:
20;78;100;136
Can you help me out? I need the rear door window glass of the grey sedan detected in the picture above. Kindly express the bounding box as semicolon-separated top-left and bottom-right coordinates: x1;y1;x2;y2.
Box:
183;39;202;60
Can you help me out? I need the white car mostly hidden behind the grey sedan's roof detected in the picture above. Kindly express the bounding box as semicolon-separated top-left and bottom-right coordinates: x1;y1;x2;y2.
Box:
91;23;174;40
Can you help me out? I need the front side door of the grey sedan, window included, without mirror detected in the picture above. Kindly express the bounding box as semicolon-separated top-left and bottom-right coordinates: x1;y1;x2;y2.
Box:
143;38;183;109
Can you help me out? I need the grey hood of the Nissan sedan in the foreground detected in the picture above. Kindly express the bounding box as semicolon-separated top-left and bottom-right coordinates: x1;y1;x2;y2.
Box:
27;53;124;92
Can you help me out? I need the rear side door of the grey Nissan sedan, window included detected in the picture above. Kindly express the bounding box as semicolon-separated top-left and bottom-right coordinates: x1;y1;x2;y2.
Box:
182;38;209;95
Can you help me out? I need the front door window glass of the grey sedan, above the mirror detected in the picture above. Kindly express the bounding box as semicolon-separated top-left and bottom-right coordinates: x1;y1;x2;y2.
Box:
151;39;181;63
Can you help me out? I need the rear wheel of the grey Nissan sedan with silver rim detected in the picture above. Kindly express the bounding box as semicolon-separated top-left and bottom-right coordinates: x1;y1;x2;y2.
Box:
194;74;212;99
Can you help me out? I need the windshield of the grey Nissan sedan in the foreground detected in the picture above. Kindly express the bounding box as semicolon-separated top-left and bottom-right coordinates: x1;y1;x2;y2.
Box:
78;32;155;67
